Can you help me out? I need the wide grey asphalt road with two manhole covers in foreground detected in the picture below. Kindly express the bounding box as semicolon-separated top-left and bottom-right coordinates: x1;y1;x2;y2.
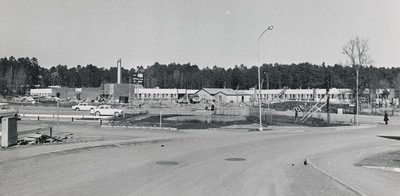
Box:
0;109;400;195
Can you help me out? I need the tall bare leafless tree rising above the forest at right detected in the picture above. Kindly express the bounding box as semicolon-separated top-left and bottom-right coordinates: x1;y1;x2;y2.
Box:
343;37;372;125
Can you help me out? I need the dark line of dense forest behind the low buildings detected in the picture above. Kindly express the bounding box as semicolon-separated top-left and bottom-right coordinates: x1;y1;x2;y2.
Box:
0;56;400;95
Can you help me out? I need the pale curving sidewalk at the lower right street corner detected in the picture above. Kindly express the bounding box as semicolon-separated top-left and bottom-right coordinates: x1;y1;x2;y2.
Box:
309;145;400;196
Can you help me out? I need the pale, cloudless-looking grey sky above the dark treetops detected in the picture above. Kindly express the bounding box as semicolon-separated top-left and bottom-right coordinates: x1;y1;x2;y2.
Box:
0;0;400;69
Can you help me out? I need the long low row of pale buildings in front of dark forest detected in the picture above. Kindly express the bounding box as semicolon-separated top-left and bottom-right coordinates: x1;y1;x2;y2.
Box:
31;84;395;103
